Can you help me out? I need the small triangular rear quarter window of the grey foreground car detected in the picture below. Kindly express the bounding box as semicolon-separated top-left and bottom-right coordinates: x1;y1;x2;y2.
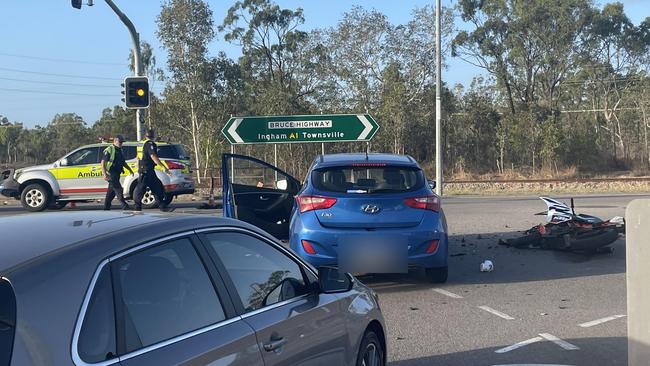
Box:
78;266;117;363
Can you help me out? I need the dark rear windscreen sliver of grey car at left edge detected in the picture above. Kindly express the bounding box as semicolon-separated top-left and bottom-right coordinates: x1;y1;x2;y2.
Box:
0;278;16;366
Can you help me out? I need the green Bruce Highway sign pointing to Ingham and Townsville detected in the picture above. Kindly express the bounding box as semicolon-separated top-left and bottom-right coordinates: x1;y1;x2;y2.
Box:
221;114;379;144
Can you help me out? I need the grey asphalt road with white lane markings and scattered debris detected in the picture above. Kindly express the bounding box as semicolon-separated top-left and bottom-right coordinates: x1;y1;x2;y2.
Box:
0;195;647;366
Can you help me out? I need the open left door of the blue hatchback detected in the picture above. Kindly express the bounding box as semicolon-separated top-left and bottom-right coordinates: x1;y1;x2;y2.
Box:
221;154;301;240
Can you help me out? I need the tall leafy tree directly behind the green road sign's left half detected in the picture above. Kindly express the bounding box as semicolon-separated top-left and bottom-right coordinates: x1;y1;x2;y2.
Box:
219;0;315;115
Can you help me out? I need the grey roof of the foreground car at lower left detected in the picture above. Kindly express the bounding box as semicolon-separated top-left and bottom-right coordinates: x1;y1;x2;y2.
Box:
0;211;249;273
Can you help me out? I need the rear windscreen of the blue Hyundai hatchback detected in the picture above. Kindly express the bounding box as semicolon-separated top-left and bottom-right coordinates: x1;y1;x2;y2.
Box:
311;165;424;194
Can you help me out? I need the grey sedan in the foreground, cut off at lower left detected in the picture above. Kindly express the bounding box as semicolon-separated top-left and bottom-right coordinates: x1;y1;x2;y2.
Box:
0;211;386;366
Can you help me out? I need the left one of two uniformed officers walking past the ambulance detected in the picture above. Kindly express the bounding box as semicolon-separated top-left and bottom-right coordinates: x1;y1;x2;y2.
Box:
101;135;133;210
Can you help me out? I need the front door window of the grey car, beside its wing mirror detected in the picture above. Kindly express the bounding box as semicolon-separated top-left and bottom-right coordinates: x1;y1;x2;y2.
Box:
206;232;309;311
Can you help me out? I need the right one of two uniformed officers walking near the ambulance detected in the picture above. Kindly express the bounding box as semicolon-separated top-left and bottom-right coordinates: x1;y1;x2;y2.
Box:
135;130;170;211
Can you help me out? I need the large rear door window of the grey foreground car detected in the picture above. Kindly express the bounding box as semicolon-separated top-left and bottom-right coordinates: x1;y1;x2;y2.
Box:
113;239;226;353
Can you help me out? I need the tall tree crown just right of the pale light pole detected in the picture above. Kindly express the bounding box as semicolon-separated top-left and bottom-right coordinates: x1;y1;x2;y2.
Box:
452;0;592;114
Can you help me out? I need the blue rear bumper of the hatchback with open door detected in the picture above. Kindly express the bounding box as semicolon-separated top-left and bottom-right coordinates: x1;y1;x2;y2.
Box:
290;216;448;268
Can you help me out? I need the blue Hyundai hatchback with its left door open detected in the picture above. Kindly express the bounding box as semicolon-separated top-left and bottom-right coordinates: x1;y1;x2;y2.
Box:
222;154;448;283
